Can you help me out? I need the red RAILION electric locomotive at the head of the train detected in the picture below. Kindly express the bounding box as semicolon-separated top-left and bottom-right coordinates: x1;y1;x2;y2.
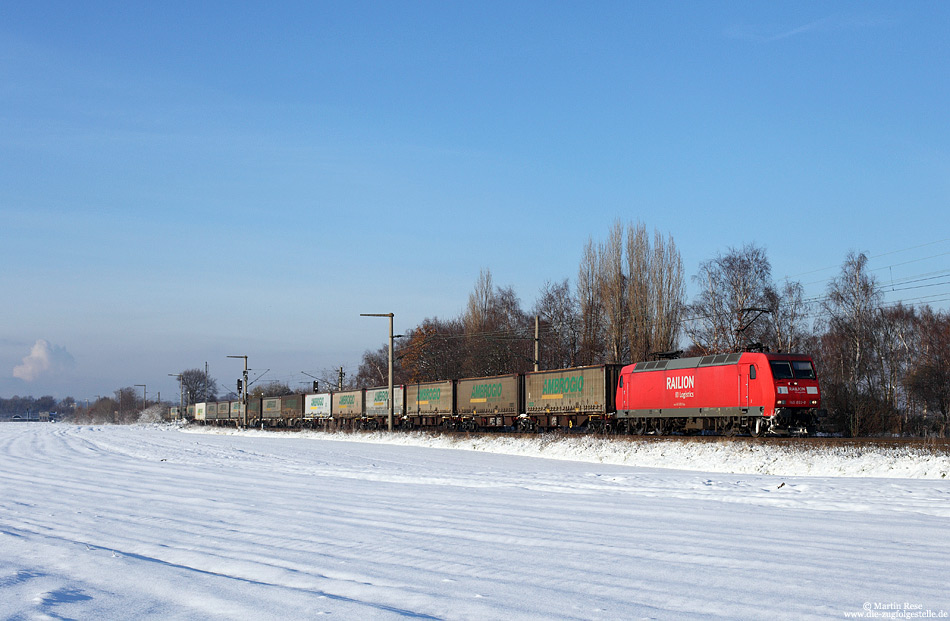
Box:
617;353;821;435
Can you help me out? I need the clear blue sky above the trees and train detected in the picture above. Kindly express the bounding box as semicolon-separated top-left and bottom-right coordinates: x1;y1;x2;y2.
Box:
0;1;950;398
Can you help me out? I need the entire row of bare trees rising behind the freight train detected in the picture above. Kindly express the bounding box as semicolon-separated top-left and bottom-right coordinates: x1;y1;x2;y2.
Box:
353;222;950;435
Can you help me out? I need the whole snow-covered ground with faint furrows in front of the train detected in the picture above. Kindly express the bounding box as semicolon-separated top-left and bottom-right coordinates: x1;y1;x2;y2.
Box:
0;423;950;619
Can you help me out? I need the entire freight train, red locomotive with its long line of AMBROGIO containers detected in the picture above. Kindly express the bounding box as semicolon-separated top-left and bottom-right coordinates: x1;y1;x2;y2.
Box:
188;352;821;436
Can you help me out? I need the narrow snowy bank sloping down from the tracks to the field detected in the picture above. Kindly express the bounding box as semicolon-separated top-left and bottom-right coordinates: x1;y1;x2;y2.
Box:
186;426;950;479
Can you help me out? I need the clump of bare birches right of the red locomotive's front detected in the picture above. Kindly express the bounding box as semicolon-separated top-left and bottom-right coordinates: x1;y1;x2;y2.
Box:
810;253;950;436
